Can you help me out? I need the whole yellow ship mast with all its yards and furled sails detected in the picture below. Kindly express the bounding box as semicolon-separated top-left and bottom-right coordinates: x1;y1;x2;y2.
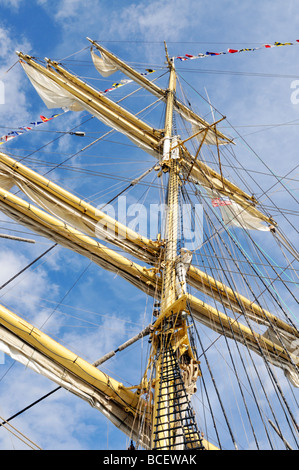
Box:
0;40;299;450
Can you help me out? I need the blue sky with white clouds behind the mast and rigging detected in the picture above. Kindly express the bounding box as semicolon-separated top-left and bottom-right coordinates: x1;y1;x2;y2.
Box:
0;0;299;450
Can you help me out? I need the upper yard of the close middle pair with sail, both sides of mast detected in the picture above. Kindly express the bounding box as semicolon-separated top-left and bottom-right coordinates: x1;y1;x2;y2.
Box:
0;153;297;360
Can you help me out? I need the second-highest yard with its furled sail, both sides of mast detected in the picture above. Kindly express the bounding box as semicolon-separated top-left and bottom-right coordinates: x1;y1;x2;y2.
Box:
18;53;273;231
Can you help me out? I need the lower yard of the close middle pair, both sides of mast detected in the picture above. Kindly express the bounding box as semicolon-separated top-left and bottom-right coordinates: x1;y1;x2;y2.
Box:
0;184;299;386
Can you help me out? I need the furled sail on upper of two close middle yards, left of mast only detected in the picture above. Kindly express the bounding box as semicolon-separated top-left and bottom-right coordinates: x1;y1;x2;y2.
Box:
0;153;160;263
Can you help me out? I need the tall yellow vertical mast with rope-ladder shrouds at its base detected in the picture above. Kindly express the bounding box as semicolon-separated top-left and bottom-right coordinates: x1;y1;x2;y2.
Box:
151;52;203;450
